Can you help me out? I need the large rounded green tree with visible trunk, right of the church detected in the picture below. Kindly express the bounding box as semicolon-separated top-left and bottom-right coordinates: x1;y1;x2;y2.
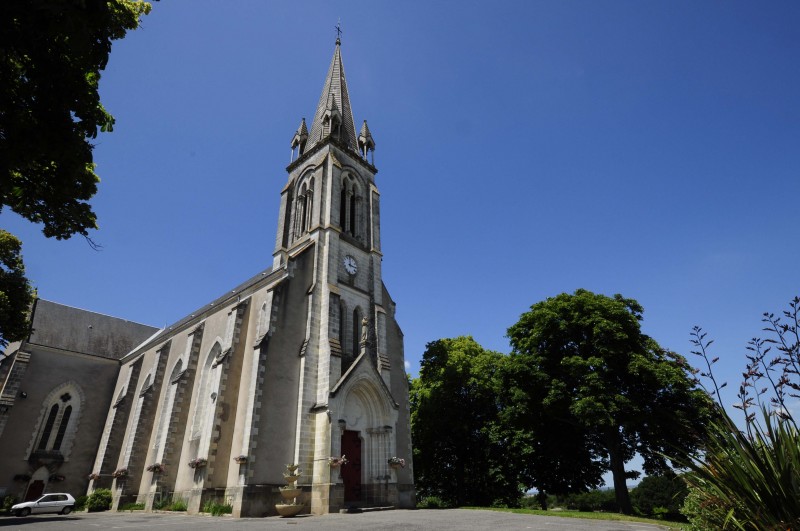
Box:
508;289;709;513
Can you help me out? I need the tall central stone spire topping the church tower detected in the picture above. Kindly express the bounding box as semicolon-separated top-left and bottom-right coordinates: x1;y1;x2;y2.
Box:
306;37;358;151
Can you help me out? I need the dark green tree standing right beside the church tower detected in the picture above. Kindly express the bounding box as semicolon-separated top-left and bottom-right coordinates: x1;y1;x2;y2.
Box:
411;337;522;506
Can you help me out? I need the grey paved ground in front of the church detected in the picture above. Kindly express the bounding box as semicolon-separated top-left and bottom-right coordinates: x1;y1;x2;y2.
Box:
0;509;665;531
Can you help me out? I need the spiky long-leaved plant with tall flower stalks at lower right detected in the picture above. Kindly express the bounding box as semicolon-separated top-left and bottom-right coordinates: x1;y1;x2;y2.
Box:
682;297;800;531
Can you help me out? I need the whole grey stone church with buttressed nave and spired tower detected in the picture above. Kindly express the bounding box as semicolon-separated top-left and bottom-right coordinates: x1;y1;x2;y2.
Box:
0;39;415;516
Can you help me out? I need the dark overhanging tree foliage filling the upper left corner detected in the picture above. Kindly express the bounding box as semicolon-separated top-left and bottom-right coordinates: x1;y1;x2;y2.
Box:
0;0;150;352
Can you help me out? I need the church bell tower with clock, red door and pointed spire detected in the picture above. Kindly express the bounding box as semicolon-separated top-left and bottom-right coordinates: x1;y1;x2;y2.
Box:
273;38;414;513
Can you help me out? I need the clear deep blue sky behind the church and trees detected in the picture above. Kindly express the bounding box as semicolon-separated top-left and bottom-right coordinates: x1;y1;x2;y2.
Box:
0;0;800;416
